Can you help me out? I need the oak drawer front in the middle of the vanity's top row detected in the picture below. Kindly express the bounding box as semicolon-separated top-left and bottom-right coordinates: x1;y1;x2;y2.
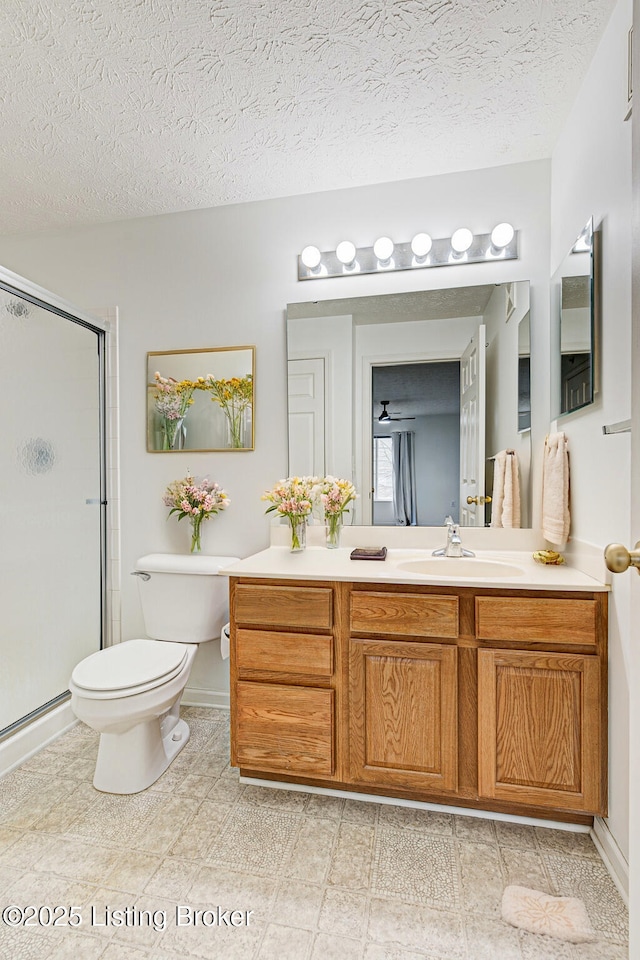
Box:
351;590;458;639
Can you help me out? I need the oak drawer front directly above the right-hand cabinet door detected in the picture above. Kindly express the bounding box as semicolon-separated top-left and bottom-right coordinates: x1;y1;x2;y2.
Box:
476;597;598;646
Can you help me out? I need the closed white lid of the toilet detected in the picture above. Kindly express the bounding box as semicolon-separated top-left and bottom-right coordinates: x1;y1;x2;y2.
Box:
71;640;189;692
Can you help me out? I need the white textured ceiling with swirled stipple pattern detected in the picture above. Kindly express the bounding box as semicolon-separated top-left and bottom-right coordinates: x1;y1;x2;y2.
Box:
0;0;615;234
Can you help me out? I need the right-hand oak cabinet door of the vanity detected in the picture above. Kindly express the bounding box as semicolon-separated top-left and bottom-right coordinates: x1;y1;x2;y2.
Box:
478;650;606;813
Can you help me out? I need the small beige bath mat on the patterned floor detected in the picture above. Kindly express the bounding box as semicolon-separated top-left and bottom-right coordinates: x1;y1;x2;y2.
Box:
502;886;597;943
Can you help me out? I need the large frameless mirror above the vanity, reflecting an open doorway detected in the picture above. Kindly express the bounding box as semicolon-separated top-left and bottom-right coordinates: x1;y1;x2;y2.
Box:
287;281;531;526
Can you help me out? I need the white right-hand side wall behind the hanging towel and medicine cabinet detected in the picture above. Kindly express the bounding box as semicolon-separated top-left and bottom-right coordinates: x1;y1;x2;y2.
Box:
548;0;632;854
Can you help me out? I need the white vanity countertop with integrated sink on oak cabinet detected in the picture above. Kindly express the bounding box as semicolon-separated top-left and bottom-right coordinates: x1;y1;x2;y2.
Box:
220;544;609;591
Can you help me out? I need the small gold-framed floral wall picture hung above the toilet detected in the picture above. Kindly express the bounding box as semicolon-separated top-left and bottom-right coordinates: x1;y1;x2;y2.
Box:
147;347;255;453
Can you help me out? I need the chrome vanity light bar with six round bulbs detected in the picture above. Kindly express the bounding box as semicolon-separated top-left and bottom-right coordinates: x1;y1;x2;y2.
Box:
298;223;518;280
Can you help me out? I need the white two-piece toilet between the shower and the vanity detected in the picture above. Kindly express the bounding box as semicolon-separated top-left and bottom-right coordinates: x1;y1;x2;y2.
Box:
69;553;238;794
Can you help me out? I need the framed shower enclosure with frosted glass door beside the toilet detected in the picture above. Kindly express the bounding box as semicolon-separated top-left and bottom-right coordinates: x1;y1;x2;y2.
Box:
0;270;106;738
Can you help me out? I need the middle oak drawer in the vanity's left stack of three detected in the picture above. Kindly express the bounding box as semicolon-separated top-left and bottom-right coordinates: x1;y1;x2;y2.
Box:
236;629;333;677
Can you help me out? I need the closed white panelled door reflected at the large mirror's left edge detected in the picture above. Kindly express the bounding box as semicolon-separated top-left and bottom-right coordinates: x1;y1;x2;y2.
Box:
288;358;325;477
